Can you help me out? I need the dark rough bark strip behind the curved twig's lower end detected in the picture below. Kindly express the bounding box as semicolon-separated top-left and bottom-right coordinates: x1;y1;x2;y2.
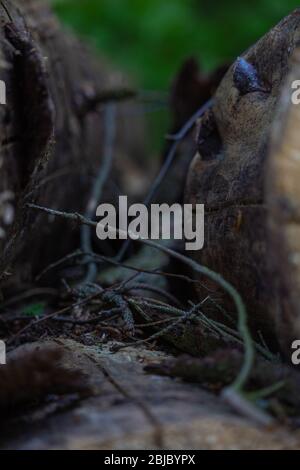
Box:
146;347;300;417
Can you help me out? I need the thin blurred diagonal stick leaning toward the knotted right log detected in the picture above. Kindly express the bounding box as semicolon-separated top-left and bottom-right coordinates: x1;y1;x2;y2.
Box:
117;100;213;261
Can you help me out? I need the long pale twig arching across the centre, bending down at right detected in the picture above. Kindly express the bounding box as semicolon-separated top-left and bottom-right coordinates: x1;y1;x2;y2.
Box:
27;204;255;392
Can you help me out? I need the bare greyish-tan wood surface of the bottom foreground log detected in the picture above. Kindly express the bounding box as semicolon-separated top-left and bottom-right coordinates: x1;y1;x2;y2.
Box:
1;340;300;450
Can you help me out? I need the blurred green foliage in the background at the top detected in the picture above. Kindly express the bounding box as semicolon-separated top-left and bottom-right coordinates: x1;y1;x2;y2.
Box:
53;0;298;89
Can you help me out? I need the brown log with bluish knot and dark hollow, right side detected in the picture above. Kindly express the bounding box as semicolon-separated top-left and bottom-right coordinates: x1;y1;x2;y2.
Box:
186;10;300;348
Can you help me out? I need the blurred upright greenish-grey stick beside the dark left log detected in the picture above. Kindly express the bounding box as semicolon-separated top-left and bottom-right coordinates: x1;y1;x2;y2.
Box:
81;103;116;285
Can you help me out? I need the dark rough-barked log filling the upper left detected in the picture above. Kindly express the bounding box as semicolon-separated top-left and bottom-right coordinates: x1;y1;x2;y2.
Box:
0;0;143;282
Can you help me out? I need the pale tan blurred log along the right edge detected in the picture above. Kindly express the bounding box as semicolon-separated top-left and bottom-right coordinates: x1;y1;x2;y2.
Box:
266;48;300;354
